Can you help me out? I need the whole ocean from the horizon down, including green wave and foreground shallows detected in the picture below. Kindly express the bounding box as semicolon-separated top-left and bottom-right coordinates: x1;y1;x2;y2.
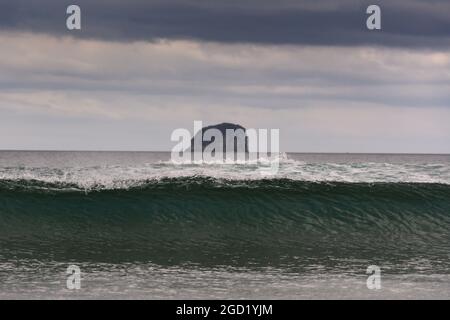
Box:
0;151;450;299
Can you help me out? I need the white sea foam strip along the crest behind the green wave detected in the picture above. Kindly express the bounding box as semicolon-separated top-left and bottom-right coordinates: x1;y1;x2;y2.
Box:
0;155;450;189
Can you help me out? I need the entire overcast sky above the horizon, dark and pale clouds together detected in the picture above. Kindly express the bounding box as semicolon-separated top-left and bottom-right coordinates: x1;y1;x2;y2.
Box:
0;0;450;153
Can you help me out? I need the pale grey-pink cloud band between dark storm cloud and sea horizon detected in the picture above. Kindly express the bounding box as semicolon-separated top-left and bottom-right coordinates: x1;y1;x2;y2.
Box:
0;32;450;153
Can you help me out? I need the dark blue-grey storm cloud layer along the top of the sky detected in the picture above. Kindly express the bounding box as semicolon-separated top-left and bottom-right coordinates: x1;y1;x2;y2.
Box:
0;0;450;48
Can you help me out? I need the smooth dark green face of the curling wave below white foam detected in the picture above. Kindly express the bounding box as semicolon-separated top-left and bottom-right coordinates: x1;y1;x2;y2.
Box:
0;176;450;273
